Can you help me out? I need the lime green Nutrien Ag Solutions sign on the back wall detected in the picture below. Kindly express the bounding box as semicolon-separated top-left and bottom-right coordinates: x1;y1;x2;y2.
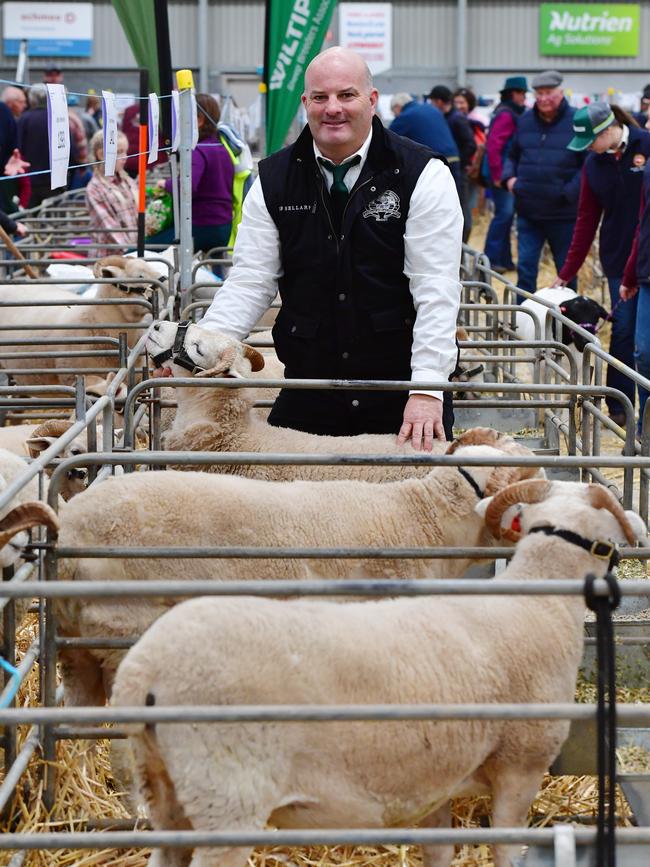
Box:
539;3;641;57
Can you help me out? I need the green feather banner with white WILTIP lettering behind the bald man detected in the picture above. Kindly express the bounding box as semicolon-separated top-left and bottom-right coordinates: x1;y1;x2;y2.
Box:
265;0;336;154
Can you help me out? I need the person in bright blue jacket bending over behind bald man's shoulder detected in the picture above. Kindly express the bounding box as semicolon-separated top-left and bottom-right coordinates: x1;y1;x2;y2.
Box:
389;93;461;195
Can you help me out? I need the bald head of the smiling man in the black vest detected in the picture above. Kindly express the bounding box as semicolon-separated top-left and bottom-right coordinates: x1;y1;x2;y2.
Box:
302;48;379;163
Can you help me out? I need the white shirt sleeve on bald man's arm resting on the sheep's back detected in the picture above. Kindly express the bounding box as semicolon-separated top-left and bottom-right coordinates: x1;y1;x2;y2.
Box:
404;159;463;399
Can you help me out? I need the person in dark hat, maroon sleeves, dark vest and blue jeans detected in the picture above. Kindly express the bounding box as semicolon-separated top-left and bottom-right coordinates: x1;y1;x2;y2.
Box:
485;75;528;274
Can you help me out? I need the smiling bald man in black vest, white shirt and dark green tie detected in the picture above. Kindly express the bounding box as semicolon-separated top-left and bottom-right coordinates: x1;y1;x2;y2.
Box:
200;48;463;450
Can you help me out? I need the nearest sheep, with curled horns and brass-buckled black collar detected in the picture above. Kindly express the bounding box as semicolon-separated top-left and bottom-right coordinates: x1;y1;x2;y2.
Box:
112;480;645;867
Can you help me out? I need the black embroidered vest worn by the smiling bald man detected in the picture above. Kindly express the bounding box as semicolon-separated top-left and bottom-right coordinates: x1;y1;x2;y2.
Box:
259;118;453;436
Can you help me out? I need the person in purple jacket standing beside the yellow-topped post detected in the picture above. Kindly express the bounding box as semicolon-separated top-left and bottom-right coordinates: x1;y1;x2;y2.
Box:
147;93;235;252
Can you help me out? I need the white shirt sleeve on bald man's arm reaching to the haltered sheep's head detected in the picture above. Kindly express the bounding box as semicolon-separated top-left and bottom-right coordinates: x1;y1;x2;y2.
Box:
199;178;282;340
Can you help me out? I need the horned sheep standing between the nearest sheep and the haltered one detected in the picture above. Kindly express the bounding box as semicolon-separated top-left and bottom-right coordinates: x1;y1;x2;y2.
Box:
45;429;538;705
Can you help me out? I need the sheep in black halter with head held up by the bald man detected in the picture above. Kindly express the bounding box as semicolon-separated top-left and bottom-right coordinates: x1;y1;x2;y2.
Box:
147;322;448;482
